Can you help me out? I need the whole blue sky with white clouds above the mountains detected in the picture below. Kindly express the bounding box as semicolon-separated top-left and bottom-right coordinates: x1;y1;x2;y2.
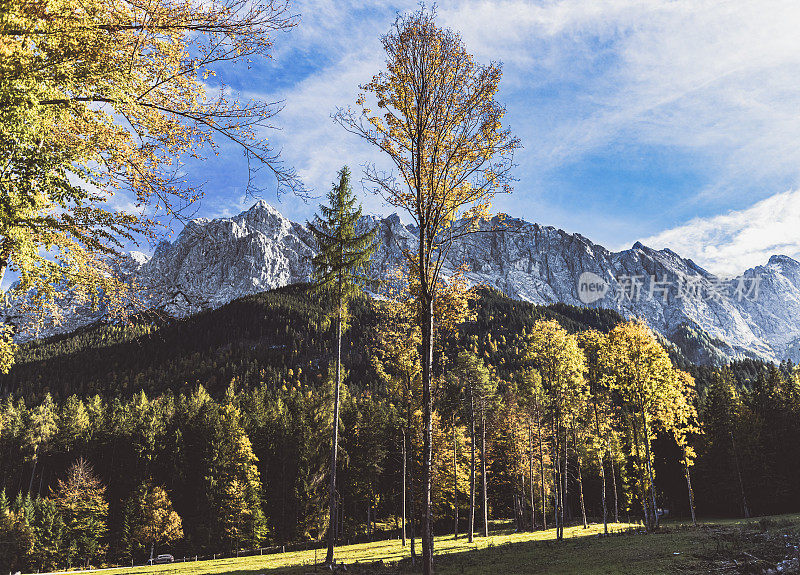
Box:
43;0;800;284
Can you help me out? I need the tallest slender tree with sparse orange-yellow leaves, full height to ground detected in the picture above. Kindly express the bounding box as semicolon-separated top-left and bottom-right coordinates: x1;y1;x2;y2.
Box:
335;8;520;575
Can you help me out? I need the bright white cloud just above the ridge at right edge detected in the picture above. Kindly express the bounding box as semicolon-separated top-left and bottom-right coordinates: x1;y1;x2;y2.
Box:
642;190;800;276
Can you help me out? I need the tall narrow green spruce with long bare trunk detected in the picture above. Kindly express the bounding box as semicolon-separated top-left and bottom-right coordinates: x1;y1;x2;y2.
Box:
308;166;375;564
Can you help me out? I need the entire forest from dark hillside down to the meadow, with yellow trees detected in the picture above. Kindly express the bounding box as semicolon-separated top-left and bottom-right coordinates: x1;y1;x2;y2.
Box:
0;290;800;570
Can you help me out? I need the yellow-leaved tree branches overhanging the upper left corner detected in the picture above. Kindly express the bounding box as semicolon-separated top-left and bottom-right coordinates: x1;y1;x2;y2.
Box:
0;0;301;369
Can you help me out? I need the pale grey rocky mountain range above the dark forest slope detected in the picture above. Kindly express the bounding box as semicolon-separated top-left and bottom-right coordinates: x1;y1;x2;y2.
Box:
6;201;800;363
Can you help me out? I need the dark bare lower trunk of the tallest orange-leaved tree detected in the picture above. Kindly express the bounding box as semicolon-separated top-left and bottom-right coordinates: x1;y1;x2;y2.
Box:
420;296;433;575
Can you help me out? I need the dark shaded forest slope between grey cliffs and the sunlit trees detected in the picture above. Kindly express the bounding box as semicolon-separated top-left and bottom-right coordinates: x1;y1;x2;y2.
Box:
0;285;622;400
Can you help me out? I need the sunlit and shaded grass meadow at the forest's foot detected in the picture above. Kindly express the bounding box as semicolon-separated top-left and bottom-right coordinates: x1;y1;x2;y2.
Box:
42;515;800;575
